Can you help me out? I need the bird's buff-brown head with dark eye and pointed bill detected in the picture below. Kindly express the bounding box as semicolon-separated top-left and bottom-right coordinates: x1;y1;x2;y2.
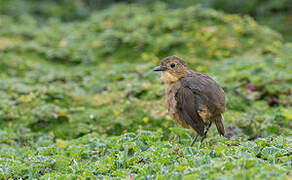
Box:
153;56;189;83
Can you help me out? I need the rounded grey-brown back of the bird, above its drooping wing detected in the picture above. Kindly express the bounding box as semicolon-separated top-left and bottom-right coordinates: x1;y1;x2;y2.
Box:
181;73;225;114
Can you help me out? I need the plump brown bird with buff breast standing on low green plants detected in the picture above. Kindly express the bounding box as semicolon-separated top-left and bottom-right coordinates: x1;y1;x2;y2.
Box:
153;56;225;146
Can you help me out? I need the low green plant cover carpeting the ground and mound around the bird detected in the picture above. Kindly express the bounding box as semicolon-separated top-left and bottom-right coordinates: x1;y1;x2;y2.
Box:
0;1;292;179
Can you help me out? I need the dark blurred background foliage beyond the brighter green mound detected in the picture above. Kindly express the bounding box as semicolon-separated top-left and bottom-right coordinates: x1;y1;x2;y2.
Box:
0;0;292;41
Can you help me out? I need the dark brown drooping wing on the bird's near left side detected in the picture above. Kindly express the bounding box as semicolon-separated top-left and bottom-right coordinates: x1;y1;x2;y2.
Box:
175;87;204;136
